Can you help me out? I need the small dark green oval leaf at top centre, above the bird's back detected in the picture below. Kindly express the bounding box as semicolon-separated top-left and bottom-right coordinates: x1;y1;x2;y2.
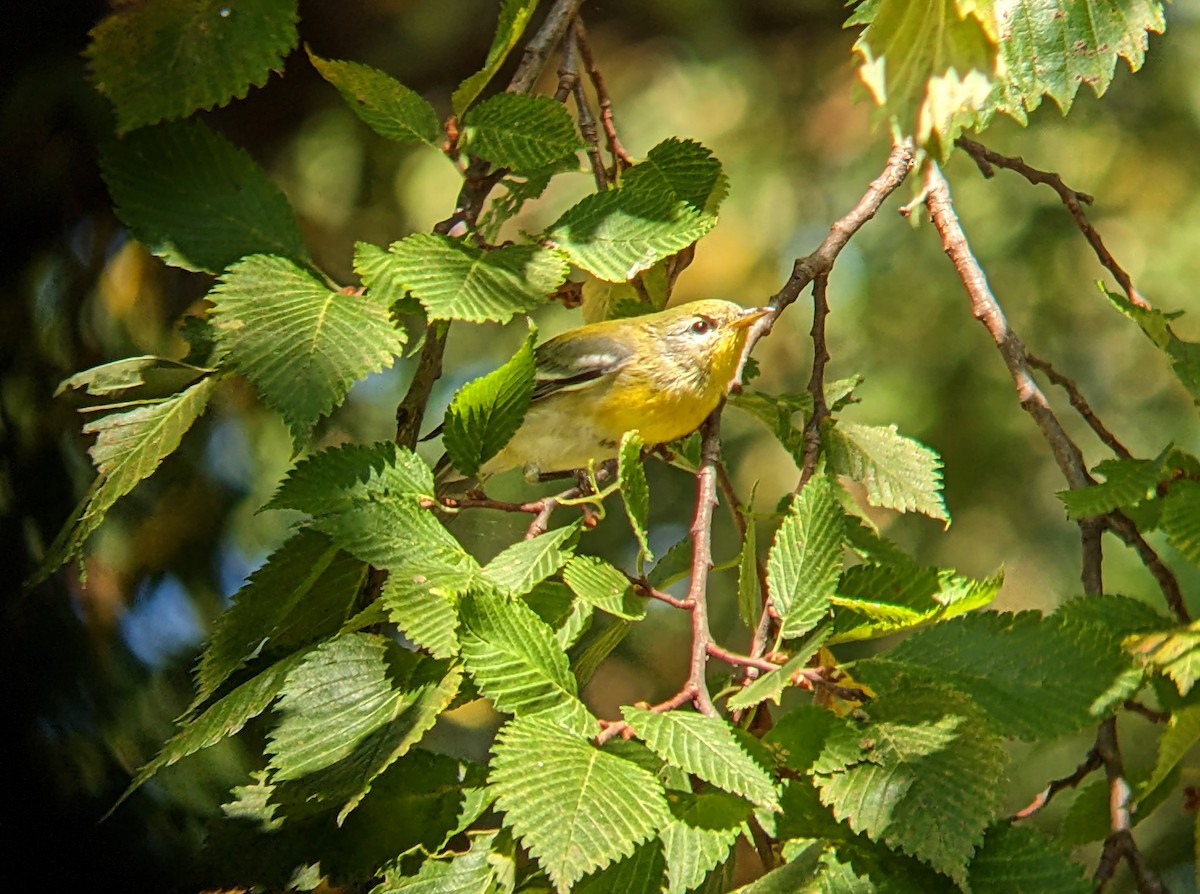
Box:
462;94;586;172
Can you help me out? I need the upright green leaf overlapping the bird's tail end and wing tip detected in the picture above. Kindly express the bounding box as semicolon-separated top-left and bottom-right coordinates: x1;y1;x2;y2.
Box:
442;324;538;475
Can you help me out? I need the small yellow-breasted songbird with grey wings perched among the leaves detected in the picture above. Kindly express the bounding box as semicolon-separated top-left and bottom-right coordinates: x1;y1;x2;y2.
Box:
438;299;773;485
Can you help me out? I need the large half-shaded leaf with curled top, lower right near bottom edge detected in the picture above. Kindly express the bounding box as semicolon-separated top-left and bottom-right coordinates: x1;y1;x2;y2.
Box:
814;688;1008;884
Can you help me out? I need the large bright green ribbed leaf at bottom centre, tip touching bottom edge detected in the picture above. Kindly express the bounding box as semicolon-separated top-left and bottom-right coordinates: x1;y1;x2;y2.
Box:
488;718;671;892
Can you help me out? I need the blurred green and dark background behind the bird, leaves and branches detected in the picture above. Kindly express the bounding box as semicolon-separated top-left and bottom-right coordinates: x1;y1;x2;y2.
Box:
9;0;1200;890
